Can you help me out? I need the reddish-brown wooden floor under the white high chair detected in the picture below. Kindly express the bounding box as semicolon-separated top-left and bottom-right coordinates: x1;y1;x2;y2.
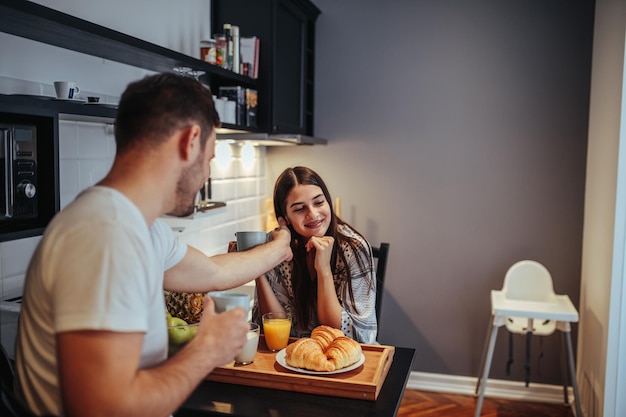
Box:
398;389;574;417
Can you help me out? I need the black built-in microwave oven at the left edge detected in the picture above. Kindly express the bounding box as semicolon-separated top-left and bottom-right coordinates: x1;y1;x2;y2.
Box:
0;112;59;242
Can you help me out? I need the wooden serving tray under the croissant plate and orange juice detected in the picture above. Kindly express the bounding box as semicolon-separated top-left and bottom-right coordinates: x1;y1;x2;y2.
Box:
206;335;395;401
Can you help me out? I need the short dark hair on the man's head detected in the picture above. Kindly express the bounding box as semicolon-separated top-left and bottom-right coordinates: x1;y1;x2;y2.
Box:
115;73;220;153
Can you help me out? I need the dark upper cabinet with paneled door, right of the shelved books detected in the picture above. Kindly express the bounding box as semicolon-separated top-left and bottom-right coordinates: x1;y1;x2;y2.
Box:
211;0;320;136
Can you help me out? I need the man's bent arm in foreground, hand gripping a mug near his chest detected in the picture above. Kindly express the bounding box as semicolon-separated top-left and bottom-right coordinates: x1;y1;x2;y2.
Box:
57;297;248;417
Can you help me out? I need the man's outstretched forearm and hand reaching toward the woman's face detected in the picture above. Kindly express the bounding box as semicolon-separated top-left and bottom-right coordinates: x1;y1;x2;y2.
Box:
163;219;293;292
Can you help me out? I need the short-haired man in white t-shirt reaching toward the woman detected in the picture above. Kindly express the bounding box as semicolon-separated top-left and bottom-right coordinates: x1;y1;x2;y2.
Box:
16;74;292;417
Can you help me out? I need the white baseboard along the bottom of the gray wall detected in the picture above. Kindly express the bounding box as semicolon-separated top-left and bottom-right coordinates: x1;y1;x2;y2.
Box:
406;372;574;404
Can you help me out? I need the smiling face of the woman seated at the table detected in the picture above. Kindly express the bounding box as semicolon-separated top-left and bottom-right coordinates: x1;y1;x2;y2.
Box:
286;185;331;240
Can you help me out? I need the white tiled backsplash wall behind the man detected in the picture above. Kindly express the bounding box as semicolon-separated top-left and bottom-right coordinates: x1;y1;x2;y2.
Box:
0;116;267;299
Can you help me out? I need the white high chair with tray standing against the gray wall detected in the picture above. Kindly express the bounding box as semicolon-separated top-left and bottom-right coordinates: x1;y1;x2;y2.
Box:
474;260;582;417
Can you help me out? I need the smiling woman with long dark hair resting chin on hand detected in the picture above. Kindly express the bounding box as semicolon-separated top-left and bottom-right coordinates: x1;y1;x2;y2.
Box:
253;167;377;343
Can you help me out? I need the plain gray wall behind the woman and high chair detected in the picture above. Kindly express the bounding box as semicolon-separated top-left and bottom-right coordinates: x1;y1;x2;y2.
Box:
268;0;593;384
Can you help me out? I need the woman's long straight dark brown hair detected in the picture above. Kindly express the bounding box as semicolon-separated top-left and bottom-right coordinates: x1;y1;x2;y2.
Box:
274;166;369;329
